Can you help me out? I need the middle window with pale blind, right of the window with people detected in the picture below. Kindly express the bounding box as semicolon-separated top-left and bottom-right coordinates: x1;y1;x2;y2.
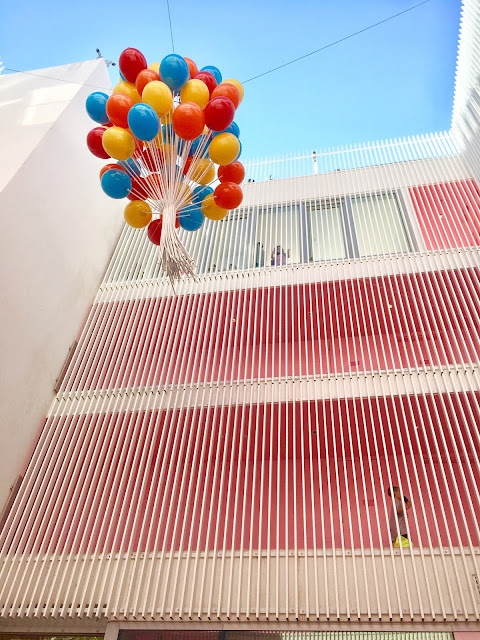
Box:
307;201;350;262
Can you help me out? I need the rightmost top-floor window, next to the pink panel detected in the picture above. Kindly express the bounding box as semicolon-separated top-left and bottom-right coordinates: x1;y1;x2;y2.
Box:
351;193;411;257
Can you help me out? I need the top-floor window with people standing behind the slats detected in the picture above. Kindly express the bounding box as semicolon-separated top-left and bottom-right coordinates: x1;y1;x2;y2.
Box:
254;205;300;267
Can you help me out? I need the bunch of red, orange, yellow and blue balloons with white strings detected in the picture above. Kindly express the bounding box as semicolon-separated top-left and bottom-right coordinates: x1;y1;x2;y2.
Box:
86;48;245;284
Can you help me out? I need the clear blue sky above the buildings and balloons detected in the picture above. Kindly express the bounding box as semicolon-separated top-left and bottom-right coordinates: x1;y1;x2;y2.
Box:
0;0;461;159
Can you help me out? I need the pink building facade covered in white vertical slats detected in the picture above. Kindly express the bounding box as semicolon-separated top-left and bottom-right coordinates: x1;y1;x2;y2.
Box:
0;0;480;639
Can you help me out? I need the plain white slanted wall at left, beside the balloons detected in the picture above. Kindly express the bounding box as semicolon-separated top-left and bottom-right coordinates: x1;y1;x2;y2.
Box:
0;60;123;511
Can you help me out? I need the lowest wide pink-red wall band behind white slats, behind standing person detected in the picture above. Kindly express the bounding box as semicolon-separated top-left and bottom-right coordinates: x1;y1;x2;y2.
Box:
5;394;480;552
